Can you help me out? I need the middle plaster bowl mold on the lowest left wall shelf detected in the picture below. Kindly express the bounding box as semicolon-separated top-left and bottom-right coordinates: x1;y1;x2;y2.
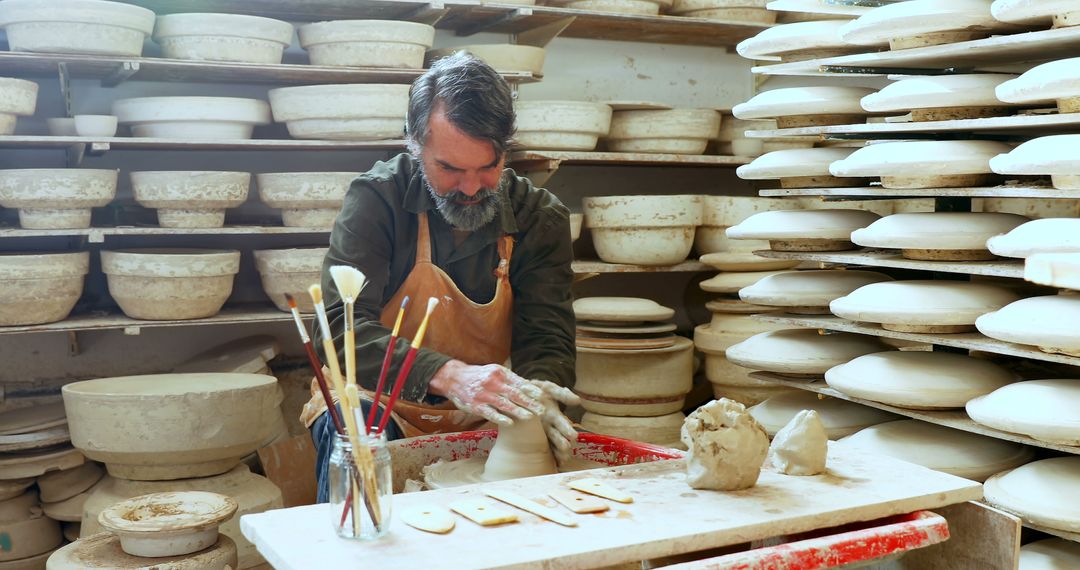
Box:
102;248;240;321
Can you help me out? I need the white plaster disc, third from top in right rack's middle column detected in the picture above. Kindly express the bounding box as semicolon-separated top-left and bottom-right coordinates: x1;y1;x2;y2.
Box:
828;139;1012;176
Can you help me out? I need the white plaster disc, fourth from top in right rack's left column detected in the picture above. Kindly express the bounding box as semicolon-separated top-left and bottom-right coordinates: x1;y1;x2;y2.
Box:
728;209;880;252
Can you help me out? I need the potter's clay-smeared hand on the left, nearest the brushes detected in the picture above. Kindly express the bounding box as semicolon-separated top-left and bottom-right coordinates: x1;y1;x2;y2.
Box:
428;361;544;425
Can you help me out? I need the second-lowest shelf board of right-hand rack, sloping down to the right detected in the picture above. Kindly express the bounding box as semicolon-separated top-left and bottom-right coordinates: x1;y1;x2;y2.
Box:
751;372;1080;454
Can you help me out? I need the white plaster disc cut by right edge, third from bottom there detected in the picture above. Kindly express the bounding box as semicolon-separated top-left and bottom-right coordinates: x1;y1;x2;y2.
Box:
967;379;1080;445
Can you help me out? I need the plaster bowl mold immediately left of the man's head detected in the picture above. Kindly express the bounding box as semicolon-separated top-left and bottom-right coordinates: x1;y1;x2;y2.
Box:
270;84;409;140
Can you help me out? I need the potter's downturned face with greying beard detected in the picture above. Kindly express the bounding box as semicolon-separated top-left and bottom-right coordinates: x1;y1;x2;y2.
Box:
420;107;504;231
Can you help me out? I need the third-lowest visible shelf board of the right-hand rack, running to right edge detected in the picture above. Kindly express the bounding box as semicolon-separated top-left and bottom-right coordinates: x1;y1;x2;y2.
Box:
754;313;1080;366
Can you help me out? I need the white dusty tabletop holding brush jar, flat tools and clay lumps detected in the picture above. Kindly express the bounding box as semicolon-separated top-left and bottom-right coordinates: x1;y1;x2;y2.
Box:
240;446;983;570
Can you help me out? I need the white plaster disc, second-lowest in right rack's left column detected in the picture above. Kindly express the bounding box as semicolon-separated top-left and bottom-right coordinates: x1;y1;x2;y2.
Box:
725;328;893;375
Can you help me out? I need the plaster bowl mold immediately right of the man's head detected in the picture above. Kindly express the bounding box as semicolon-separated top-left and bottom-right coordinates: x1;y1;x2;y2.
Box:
514;100;611;150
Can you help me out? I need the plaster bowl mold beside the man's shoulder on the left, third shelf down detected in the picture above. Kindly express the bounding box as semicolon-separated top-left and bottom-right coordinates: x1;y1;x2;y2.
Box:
255;172;360;229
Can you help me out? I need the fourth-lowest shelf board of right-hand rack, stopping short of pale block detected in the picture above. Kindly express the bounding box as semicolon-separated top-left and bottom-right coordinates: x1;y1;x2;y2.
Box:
754;249;1024;279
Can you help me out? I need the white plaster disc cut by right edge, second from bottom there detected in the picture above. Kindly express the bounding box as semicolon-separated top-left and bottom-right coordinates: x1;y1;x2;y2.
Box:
983;456;1080;532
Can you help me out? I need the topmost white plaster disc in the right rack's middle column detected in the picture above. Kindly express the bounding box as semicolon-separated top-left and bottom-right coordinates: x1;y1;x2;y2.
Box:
840;0;1023;50
